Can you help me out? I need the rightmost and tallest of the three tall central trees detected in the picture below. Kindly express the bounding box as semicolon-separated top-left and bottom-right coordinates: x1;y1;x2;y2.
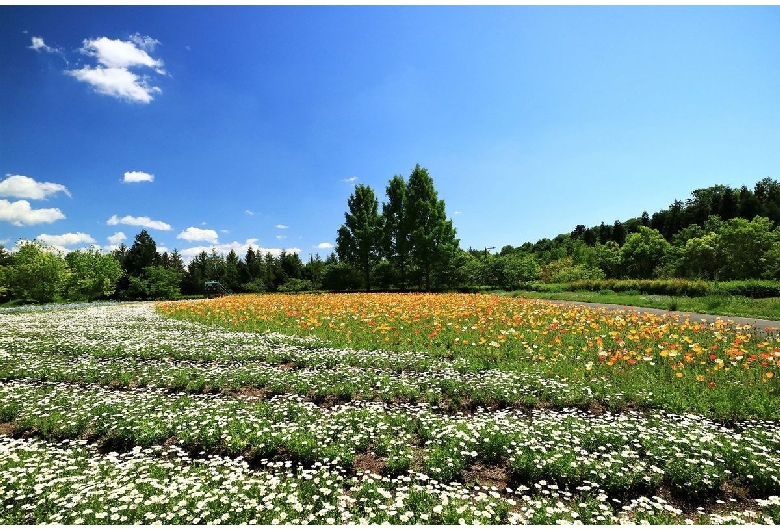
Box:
407;164;458;290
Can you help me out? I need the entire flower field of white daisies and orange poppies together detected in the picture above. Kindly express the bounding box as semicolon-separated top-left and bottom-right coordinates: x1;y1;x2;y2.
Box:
0;294;780;524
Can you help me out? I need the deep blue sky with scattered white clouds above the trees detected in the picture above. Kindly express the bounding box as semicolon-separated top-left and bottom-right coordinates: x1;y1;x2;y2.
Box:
0;6;780;260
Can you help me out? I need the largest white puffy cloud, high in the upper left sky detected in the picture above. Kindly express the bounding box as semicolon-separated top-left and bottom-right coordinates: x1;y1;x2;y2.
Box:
66;34;166;103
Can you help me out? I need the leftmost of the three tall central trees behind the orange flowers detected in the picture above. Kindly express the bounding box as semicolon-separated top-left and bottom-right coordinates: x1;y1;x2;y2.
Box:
336;184;382;291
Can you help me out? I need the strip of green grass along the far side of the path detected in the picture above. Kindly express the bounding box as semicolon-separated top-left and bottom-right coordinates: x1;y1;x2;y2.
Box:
510;290;780;320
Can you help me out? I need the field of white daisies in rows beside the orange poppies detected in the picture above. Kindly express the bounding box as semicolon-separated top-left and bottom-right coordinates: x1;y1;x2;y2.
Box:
0;296;780;524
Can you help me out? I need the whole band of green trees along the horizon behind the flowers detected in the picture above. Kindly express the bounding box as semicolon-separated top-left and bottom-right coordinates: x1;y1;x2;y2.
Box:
0;171;780;303
